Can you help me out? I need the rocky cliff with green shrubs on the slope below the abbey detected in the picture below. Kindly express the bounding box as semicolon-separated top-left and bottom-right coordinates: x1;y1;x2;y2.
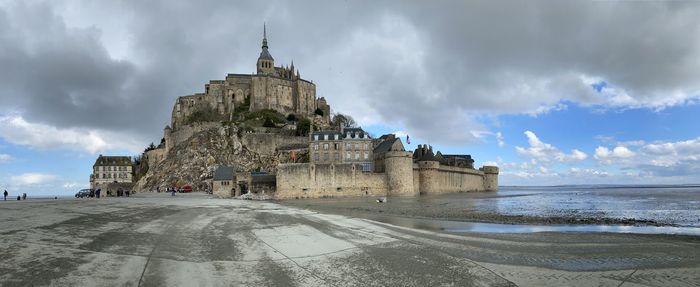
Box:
134;123;306;192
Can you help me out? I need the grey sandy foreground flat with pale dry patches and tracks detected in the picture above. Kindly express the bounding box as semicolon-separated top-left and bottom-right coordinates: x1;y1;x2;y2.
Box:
0;194;700;286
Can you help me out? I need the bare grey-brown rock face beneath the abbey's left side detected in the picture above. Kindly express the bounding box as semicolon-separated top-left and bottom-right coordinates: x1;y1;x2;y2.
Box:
134;122;298;192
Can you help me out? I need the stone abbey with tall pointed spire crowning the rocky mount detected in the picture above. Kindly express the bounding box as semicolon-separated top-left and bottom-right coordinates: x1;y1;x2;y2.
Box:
170;28;330;130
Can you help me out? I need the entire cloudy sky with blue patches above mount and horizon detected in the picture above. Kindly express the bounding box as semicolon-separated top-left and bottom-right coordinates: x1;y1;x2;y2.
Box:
0;0;700;195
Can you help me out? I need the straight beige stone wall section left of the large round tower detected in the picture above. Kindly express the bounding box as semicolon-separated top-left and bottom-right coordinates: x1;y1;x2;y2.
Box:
274;163;388;199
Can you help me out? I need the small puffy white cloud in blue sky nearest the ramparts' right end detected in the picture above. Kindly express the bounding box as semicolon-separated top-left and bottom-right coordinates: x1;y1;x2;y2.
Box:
515;131;588;163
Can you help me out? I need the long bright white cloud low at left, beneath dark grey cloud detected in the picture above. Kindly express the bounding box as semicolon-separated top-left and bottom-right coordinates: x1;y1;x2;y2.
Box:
0;116;141;154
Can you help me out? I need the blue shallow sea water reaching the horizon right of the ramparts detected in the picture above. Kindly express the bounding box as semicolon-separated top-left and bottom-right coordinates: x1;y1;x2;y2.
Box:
490;186;700;227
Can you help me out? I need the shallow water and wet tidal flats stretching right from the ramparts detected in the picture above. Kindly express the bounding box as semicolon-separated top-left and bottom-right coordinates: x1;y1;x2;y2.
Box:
290;186;700;235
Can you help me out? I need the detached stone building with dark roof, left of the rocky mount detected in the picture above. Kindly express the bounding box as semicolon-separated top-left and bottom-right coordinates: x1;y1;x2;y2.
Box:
90;155;133;189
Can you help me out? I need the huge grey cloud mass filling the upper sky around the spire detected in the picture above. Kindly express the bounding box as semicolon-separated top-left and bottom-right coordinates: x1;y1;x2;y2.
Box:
0;0;700;151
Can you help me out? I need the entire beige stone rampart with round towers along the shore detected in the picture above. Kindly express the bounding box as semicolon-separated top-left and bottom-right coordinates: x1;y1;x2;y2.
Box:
274;160;498;199
